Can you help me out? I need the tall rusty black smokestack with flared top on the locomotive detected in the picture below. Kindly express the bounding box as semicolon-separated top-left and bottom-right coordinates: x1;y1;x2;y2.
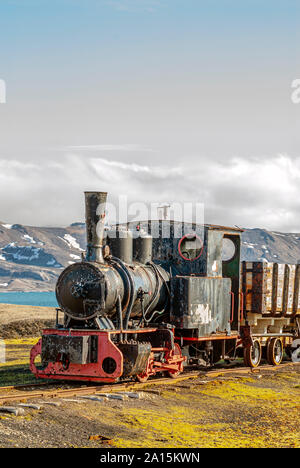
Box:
84;192;107;263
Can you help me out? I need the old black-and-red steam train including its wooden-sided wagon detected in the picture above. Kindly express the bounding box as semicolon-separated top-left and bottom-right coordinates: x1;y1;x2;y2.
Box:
30;192;300;382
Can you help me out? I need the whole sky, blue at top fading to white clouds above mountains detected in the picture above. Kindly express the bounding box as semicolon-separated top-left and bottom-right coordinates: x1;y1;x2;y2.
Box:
0;0;300;232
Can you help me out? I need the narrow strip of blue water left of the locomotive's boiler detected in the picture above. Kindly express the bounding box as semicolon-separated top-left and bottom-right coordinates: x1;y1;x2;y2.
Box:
0;292;58;307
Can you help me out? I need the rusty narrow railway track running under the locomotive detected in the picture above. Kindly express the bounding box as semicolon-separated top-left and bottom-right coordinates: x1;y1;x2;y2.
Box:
0;363;300;405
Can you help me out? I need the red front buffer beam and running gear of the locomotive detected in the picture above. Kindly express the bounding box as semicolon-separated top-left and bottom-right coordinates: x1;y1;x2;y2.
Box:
30;329;185;383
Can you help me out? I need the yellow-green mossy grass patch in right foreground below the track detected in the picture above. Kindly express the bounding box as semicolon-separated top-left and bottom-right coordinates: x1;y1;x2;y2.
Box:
116;379;300;448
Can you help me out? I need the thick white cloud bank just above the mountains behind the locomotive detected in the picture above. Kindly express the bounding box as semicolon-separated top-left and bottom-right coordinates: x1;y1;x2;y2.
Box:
0;152;300;232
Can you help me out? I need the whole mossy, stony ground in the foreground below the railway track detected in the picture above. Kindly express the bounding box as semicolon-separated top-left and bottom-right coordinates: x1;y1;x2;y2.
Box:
0;366;300;448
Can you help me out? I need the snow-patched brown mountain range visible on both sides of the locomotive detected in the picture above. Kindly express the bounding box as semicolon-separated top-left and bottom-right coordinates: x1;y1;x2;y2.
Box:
0;222;300;292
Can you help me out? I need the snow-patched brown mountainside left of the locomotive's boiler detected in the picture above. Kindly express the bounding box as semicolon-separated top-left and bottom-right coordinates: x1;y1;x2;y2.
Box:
0;223;85;292
